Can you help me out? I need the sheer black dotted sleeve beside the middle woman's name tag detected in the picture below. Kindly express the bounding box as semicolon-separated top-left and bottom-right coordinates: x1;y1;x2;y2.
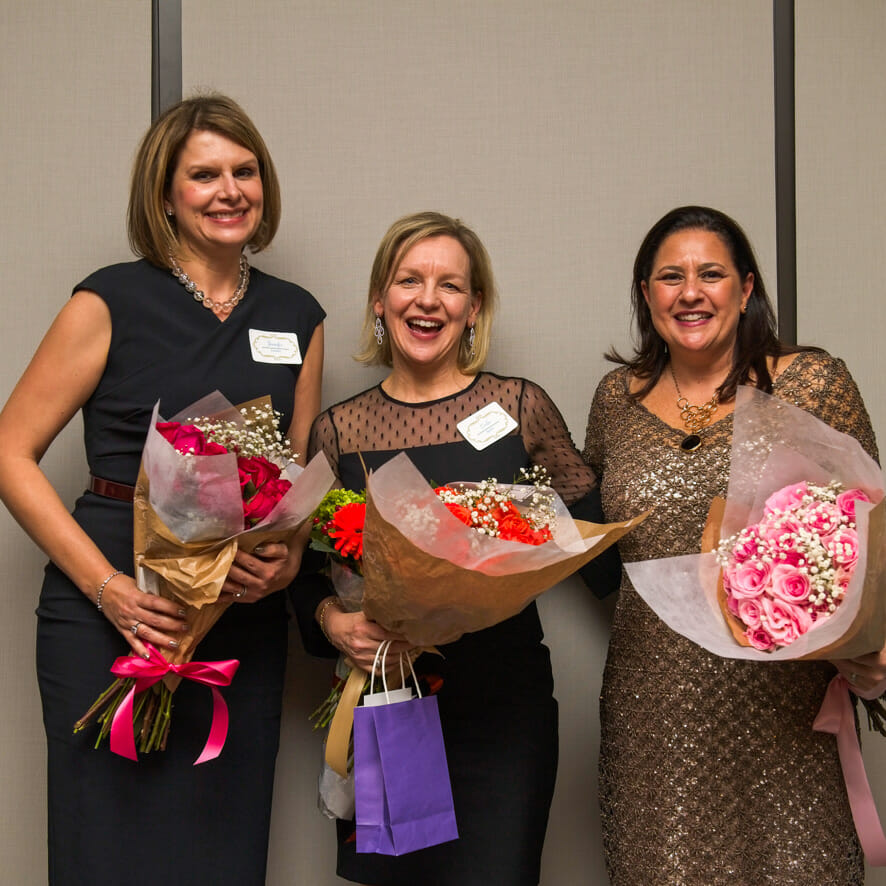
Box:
520;381;596;505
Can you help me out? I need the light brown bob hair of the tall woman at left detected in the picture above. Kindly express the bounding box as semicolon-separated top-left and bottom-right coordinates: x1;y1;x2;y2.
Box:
127;93;280;268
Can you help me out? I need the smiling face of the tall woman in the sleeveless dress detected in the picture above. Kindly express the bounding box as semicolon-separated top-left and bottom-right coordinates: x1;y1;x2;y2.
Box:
164;130;264;257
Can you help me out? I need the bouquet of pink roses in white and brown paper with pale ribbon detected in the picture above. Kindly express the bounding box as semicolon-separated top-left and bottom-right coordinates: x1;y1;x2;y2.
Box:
625;387;886;865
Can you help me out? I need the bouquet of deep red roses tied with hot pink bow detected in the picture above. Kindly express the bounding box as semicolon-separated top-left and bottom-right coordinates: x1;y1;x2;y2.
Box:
75;392;334;762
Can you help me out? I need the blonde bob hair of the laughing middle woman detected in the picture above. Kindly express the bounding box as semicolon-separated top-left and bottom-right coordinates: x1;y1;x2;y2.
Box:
354;212;498;375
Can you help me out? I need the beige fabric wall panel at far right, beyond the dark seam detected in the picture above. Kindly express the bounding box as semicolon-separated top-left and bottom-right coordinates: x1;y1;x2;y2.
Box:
796;0;886;886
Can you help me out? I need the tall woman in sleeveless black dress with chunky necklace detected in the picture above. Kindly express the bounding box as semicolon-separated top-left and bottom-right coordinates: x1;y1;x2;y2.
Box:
0;95;324;886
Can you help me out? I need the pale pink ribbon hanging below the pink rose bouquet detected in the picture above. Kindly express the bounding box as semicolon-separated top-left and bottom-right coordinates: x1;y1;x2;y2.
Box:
812;674;886;867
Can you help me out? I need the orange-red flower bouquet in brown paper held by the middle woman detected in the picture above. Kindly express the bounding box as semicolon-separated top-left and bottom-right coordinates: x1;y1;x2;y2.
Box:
320;453;646;794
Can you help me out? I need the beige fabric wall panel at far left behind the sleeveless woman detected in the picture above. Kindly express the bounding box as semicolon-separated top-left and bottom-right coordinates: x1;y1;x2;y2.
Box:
0;0;151;883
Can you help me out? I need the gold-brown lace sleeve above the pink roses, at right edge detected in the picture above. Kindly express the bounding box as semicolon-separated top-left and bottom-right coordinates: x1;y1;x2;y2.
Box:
774;351;879;462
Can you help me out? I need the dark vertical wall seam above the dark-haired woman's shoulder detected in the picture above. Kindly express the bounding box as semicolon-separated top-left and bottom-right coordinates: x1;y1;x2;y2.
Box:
772;0;797;344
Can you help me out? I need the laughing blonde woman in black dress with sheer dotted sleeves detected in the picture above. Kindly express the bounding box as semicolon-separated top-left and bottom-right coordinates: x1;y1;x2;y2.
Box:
298;213;618;886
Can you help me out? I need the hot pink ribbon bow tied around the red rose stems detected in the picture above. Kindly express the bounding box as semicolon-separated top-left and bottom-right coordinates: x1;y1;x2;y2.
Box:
111;643;240;766
